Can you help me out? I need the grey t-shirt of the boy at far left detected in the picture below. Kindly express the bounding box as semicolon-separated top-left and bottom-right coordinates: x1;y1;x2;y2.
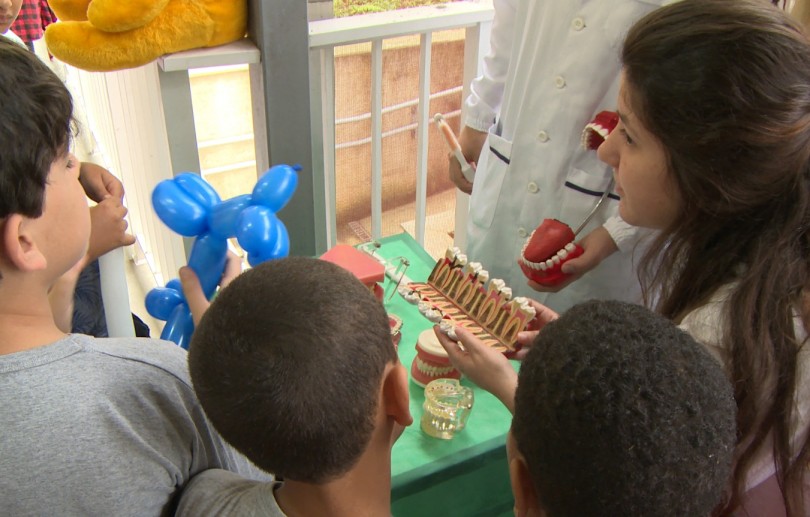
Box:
0;334;269;516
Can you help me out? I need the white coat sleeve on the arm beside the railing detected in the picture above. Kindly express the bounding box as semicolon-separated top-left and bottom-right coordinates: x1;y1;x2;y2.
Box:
464;0;519;131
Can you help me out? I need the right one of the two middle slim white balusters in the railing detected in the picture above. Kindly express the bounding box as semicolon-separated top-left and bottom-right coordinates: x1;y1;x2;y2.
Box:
416;32;433;246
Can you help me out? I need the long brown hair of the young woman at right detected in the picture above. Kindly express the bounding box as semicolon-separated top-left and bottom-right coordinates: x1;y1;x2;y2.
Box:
622;0;810;515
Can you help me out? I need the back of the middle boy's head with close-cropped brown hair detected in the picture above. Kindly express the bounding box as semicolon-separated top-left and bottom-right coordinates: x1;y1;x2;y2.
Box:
189;257;397;483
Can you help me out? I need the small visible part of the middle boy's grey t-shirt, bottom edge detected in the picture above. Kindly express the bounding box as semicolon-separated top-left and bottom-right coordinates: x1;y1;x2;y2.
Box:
177;469;285;517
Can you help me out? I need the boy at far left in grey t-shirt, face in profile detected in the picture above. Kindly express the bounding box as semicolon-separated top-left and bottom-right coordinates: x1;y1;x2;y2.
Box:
0;38;266;515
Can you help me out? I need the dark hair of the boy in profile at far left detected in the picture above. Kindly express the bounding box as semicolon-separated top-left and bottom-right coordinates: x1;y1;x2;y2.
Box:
0;37;73;217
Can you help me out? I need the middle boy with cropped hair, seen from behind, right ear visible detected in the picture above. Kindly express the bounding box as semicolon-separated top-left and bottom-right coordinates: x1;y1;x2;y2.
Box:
178;257;412;516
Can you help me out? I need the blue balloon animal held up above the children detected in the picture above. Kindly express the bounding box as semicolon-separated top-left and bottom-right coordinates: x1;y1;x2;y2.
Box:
145;165;300;349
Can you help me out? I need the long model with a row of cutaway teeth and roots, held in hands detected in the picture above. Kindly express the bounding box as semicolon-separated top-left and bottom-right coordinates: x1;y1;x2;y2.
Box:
399;248;535;354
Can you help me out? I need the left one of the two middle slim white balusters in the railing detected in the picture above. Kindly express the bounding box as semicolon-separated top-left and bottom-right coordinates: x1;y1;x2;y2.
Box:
371;39;383;239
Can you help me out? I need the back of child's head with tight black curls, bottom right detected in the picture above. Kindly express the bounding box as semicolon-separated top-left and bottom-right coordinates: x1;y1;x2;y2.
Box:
512;301;736;517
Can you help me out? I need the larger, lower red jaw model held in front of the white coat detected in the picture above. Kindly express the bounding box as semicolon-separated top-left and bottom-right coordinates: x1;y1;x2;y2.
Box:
518;219;585;286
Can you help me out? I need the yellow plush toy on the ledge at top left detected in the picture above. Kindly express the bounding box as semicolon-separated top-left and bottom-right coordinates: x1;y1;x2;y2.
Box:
45;0;247;72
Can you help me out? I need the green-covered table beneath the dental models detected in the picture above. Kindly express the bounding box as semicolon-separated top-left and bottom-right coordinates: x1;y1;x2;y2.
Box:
376;233;516;517
